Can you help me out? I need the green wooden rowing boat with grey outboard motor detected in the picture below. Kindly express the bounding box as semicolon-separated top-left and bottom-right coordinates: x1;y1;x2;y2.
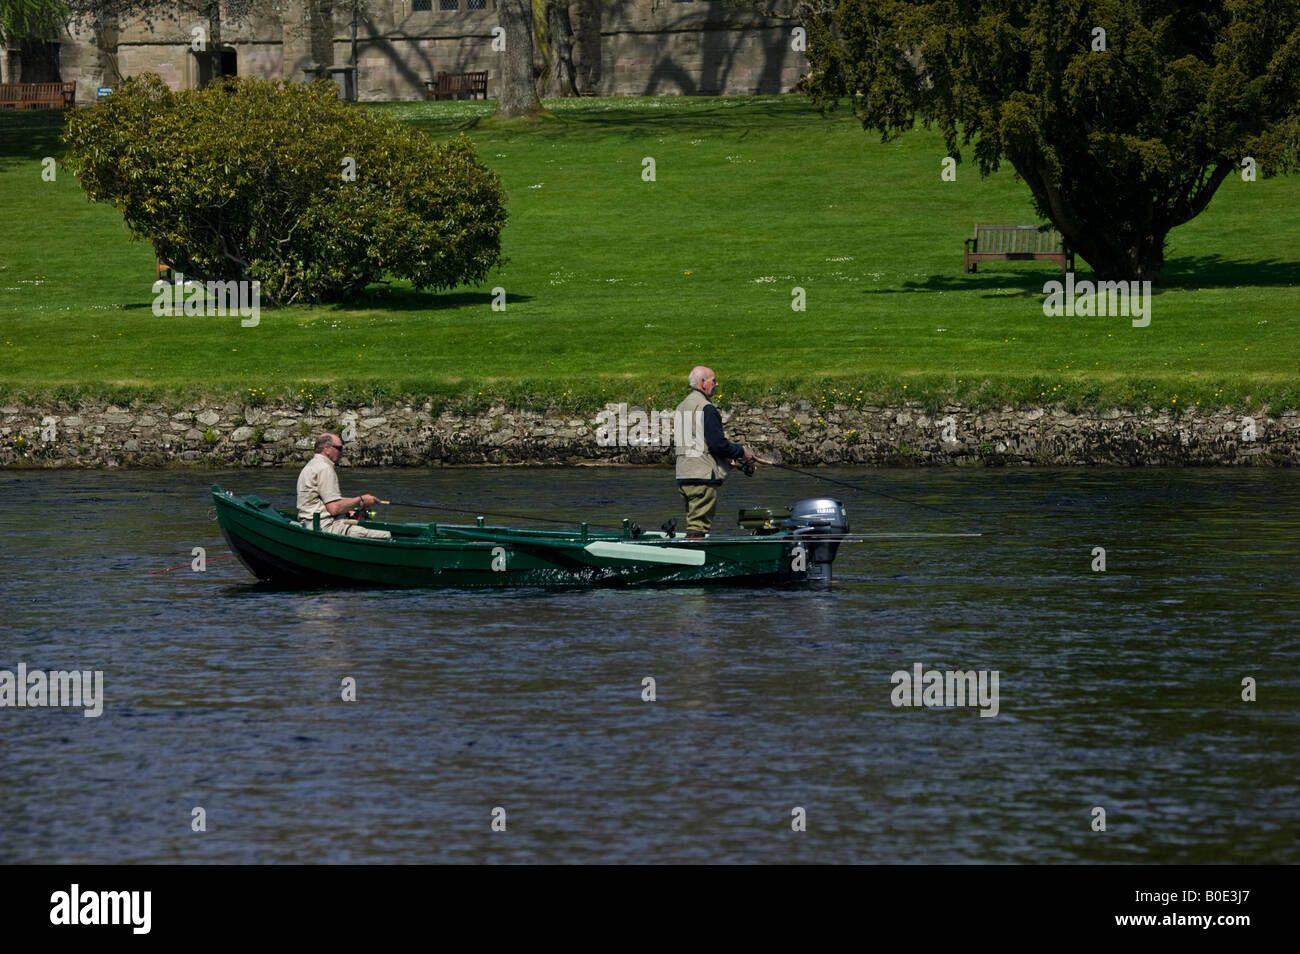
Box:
212;485;849;589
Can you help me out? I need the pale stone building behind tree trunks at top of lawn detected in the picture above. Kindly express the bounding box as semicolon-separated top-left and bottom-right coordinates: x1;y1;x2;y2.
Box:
0;0;806;103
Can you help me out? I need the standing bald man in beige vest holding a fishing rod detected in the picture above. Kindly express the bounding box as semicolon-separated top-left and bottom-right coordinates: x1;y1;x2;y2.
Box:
673;365;754;539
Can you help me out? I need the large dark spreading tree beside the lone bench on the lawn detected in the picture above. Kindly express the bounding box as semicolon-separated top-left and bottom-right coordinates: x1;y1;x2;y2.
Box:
801;0;1300;279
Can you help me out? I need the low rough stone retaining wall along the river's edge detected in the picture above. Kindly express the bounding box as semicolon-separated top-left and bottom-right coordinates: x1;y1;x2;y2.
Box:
0;403;1300;468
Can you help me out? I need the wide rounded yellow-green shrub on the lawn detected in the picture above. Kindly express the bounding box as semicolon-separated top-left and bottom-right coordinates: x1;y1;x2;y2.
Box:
64;73;506;304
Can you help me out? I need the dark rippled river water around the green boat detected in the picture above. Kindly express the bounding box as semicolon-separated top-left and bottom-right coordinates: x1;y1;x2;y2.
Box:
0;468;1300;863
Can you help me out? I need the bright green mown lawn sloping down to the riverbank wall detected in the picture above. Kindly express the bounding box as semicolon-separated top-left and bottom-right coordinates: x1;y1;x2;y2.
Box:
0;96;1300;411
